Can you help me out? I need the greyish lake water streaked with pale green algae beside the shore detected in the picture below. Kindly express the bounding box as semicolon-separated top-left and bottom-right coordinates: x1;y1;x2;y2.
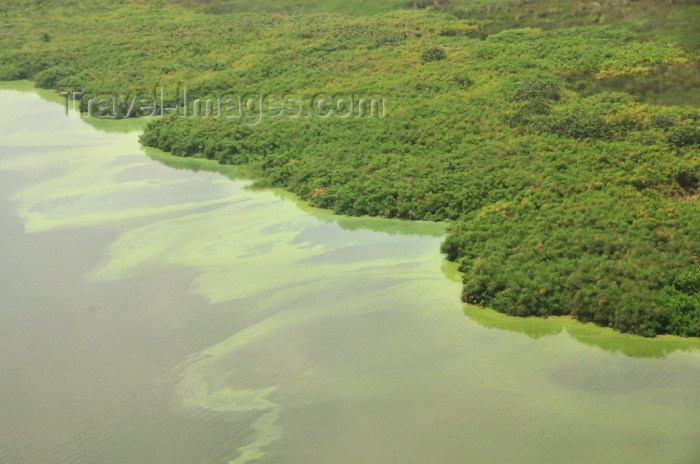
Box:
0;83;700;464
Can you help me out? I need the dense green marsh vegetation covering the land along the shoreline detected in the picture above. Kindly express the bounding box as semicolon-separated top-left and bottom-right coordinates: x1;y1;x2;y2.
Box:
0;0;700;336
